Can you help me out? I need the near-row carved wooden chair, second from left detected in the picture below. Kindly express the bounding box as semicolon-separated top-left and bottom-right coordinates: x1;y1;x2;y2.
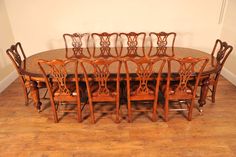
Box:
79;59;121;123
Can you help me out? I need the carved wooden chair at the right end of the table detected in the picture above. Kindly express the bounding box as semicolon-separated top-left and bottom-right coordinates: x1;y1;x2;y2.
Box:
207;39;233;103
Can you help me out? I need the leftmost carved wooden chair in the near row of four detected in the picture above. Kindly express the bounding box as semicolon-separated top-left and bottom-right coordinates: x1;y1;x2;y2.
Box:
38;59;84;123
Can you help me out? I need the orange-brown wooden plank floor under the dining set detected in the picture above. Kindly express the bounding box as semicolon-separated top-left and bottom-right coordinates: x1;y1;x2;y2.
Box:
0;75;236;157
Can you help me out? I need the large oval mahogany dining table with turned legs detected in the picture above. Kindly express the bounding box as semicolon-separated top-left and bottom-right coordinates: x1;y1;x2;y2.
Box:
22;47;217;111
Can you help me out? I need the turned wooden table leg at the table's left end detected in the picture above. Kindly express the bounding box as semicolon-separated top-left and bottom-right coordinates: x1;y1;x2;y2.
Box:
30;81;42;112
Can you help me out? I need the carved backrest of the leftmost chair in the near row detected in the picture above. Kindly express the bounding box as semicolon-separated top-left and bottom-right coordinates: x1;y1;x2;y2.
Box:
38;59;80;101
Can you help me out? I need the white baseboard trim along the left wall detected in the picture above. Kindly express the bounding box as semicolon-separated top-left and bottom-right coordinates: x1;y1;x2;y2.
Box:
0;71;18;93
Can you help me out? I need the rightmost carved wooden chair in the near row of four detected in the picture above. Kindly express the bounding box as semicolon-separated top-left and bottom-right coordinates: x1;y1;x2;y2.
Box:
161;57;209;121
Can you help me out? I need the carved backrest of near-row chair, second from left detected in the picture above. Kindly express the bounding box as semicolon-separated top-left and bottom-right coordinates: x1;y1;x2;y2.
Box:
79;59;121;99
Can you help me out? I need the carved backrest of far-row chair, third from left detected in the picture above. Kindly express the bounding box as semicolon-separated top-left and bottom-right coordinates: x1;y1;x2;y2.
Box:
119;32;146;57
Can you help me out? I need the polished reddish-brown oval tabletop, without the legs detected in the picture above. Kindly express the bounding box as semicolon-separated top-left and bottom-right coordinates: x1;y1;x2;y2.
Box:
23;47;216;81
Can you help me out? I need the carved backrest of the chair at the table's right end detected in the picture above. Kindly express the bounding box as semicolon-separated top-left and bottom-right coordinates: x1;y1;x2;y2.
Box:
211;39;233;71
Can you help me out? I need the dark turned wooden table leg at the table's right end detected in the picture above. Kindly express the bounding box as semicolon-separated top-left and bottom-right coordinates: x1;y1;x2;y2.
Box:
198;78;208;112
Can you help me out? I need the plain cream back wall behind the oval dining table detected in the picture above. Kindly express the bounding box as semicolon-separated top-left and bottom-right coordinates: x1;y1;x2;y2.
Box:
5;0;222;56
